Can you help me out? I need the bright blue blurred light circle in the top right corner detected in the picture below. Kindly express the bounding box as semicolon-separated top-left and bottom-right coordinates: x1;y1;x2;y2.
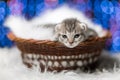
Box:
100;0;114;14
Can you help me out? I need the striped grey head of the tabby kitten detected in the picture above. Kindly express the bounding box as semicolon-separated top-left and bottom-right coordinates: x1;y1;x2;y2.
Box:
55;18;87;48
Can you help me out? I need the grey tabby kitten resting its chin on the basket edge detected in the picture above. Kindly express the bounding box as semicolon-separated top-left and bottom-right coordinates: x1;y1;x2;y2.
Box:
41;18;97;48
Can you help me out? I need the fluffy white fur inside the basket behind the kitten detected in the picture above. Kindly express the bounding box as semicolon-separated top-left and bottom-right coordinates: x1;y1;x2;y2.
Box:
4;5;105;40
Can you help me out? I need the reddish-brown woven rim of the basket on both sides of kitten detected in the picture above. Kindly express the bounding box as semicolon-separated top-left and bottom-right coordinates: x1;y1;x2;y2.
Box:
7;30;111;46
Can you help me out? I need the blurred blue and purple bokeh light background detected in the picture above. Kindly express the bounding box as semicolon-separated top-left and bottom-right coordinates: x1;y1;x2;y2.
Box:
0;0;120;53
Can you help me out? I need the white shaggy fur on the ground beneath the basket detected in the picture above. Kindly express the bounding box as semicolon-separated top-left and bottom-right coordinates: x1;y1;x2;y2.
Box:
0;48;120;80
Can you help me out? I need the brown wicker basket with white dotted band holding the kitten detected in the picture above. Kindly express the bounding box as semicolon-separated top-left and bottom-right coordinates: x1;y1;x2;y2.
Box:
8;32;110;71
